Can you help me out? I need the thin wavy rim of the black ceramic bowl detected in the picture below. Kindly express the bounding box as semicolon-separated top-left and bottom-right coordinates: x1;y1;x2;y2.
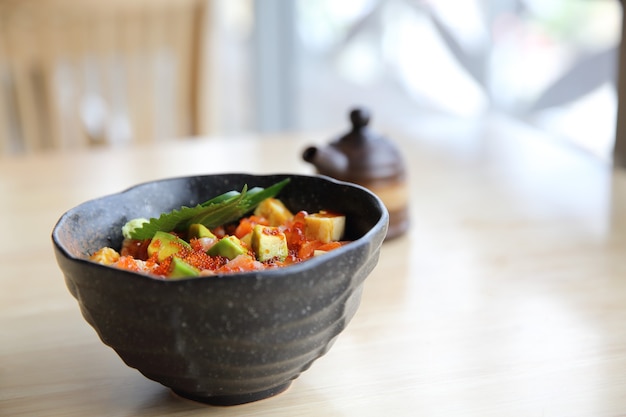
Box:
51;172;389;285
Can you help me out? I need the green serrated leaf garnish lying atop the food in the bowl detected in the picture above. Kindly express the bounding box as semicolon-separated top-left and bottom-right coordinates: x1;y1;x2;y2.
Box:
128;178;290;240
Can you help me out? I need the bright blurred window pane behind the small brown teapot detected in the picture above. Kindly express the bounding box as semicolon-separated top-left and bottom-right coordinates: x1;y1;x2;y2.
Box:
295;0;622;158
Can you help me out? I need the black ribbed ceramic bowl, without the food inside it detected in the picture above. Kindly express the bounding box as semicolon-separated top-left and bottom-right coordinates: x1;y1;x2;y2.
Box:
52;174;388;405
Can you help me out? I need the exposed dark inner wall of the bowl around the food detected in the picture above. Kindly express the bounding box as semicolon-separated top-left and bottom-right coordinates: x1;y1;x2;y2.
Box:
52;174;388;266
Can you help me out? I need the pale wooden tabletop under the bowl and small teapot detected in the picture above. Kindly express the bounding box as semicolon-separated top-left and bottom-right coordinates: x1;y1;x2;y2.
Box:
0;114;626;417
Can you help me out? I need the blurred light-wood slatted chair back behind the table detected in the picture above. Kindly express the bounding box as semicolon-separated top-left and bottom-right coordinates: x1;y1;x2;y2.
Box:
0;0;206;154
